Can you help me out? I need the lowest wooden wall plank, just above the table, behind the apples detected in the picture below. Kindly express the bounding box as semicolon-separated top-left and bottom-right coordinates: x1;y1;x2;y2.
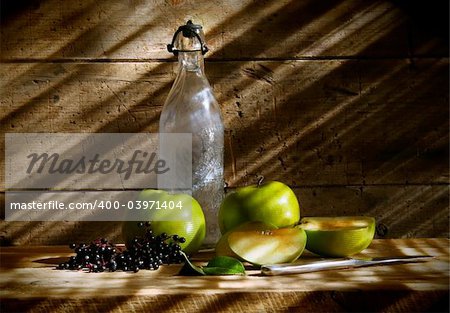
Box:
0;186;450;245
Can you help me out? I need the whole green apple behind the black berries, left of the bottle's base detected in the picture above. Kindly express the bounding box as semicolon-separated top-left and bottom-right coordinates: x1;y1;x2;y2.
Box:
122;190;206;254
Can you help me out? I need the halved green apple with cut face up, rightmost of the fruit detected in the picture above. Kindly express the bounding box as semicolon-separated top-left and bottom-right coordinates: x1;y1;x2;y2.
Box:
297;216;375;257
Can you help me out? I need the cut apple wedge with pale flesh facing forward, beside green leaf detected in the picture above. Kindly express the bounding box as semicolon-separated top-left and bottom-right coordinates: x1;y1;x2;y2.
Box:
228;228;306;264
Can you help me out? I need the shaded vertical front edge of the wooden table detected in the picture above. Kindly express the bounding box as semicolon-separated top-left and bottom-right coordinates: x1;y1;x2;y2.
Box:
0;290;448;313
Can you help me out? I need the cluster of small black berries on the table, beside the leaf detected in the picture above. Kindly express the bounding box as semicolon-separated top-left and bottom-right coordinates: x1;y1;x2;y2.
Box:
57;222;186;272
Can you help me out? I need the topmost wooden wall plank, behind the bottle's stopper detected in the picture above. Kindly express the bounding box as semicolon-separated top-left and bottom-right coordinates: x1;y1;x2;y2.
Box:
1;0;428;59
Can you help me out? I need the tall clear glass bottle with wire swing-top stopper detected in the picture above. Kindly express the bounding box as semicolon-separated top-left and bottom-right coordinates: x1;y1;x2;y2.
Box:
159;21;224;246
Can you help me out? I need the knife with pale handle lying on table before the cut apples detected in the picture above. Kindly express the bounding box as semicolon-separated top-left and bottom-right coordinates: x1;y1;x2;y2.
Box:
261;255;433;275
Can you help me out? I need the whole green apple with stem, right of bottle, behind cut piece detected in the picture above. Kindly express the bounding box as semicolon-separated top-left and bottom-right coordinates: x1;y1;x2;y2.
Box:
219;181;300;234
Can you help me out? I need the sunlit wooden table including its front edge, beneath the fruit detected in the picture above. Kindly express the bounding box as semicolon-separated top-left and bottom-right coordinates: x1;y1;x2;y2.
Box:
0;239;449;313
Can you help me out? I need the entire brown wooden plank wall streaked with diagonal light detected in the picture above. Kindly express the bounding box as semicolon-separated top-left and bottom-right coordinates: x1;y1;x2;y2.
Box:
0;0;449;244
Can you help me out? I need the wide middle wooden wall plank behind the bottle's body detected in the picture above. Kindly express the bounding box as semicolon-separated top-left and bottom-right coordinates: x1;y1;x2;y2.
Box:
0;59;449;186
